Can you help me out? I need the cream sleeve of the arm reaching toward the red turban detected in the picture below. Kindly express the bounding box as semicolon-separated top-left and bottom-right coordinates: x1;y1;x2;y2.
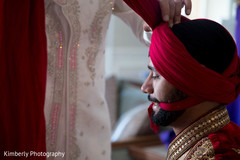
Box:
113;0;148;45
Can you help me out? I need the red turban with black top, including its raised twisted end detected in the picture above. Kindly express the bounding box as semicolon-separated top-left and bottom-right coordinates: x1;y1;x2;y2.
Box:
124;0;240;112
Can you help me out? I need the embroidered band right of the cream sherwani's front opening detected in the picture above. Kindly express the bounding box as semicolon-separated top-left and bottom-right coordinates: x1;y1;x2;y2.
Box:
62;0;81;160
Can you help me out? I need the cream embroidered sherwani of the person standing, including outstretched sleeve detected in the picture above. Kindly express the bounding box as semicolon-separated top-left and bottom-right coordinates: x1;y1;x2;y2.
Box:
45;0;142;160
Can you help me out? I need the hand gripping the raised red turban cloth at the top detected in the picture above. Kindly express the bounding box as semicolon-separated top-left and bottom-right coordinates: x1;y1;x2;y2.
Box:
143;0;192;32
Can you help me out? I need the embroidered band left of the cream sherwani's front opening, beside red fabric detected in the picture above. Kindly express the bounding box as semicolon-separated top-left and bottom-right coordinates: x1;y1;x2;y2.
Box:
45;2;65;151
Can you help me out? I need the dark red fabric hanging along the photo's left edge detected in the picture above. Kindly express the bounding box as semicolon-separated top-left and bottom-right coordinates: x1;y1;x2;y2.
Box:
0;0;47;160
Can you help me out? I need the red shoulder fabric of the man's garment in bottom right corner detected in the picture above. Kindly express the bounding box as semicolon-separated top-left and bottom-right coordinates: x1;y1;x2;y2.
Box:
208;122;240;160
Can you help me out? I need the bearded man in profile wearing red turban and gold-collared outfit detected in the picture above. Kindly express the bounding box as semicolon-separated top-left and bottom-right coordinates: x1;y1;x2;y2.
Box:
125;0;240;160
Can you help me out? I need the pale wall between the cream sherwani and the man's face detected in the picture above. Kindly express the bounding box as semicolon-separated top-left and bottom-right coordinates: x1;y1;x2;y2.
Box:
106;16;148;80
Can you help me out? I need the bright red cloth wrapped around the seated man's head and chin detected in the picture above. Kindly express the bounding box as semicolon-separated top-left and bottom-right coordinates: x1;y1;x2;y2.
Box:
149;23;240;111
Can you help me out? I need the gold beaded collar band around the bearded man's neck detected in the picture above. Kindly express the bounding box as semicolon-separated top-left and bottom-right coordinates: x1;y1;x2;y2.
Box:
167;106;230;160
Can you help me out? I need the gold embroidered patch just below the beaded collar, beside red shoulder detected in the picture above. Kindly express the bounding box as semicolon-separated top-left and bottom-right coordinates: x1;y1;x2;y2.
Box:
185;137;215;160
